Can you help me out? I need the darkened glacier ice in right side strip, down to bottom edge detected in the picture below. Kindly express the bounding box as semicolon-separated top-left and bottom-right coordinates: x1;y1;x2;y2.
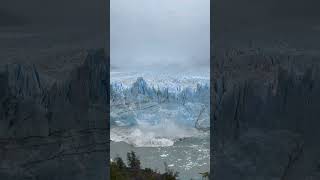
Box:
212;49;320;180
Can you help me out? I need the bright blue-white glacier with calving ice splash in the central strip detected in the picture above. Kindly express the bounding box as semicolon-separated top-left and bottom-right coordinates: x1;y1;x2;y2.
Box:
110;72;210;147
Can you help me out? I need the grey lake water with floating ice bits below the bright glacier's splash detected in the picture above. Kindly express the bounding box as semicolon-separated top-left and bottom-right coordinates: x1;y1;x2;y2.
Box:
110;134;210;180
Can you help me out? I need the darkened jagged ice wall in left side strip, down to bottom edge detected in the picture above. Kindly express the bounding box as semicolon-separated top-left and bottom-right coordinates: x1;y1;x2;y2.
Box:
0;50;109;180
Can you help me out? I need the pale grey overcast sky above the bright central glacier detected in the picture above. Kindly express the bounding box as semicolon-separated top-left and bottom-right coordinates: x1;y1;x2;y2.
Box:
110;0;210;70
